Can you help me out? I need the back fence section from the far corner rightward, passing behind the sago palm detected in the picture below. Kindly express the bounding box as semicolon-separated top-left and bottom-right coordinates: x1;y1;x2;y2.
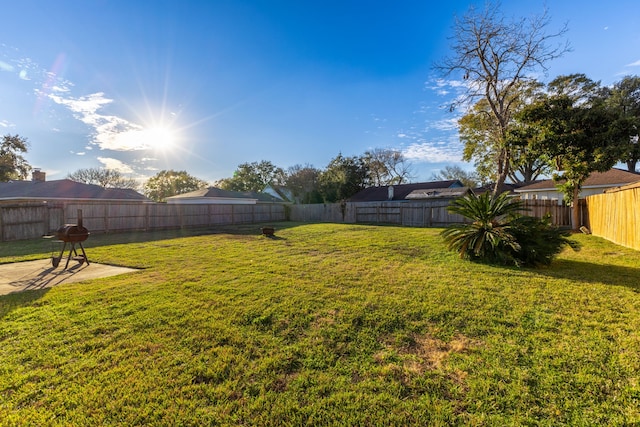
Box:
290;199;576;227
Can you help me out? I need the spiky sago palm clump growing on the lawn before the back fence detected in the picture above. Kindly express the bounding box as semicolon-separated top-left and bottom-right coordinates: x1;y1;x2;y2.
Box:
442;192;577;266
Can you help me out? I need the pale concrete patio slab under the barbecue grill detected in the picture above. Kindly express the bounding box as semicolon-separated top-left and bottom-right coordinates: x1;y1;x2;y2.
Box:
0;258;138;295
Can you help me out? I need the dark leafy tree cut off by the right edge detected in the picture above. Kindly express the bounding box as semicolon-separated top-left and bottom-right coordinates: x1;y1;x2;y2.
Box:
607;76;640;172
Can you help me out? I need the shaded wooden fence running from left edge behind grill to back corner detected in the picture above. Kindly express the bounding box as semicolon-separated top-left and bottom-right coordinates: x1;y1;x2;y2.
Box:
0;202;286;241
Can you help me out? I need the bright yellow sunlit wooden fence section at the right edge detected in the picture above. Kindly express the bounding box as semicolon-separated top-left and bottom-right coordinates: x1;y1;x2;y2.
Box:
587;182;640;250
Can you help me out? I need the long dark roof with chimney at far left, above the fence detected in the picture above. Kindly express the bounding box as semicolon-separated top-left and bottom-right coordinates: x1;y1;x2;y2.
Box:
0;179;150;202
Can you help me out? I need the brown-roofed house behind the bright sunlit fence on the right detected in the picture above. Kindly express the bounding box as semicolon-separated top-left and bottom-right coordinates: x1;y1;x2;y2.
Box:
514;168;640;204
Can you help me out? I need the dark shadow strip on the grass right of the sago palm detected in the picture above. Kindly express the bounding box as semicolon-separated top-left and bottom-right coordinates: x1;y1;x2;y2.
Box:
535;259;640;292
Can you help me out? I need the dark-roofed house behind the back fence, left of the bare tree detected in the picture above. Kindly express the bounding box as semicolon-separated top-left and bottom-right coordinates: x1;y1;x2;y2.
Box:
348;179;469;202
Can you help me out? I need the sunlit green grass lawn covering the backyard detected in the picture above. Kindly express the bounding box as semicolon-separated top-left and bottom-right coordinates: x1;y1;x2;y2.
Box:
0;223;640;426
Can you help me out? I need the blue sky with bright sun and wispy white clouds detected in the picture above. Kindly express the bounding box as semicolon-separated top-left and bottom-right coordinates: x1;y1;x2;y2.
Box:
0;0;640;186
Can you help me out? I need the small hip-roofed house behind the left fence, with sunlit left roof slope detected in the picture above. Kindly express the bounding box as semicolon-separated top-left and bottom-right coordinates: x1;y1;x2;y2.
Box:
167;187;283;205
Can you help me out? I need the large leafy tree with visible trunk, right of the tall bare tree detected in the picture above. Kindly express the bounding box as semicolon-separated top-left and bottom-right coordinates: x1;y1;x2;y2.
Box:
520;74;621;228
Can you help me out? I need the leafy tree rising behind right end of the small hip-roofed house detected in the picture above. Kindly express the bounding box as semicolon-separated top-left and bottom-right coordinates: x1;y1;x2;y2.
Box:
216;160;285;192
